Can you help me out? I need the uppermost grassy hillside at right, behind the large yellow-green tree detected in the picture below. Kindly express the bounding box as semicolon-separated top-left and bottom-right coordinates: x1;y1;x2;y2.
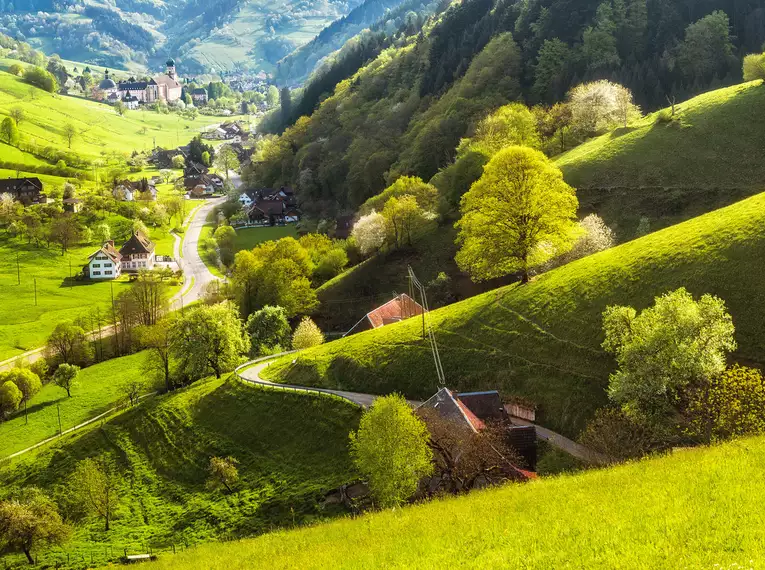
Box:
556;81;765;236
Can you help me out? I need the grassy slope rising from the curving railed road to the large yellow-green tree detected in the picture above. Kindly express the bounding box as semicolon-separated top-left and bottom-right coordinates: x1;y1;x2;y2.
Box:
269;194;765;435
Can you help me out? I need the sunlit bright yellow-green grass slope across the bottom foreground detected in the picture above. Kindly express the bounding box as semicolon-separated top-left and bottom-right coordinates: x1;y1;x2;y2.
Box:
148;432;765;570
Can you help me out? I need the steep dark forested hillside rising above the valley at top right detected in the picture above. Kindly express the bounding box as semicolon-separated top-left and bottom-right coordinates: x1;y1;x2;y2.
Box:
249;0;765;215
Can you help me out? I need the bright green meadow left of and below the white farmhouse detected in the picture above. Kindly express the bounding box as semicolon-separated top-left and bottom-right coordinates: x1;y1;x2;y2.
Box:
0;228;177;361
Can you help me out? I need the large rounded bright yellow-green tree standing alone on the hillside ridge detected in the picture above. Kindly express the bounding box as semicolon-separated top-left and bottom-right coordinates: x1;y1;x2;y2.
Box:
456;147;578;283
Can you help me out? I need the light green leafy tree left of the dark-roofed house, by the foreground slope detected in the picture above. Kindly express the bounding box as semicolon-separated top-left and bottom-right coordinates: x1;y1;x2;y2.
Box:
351;394;433;507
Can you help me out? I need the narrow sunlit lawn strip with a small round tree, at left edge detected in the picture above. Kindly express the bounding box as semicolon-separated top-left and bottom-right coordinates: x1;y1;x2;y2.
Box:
0;353;146;459
